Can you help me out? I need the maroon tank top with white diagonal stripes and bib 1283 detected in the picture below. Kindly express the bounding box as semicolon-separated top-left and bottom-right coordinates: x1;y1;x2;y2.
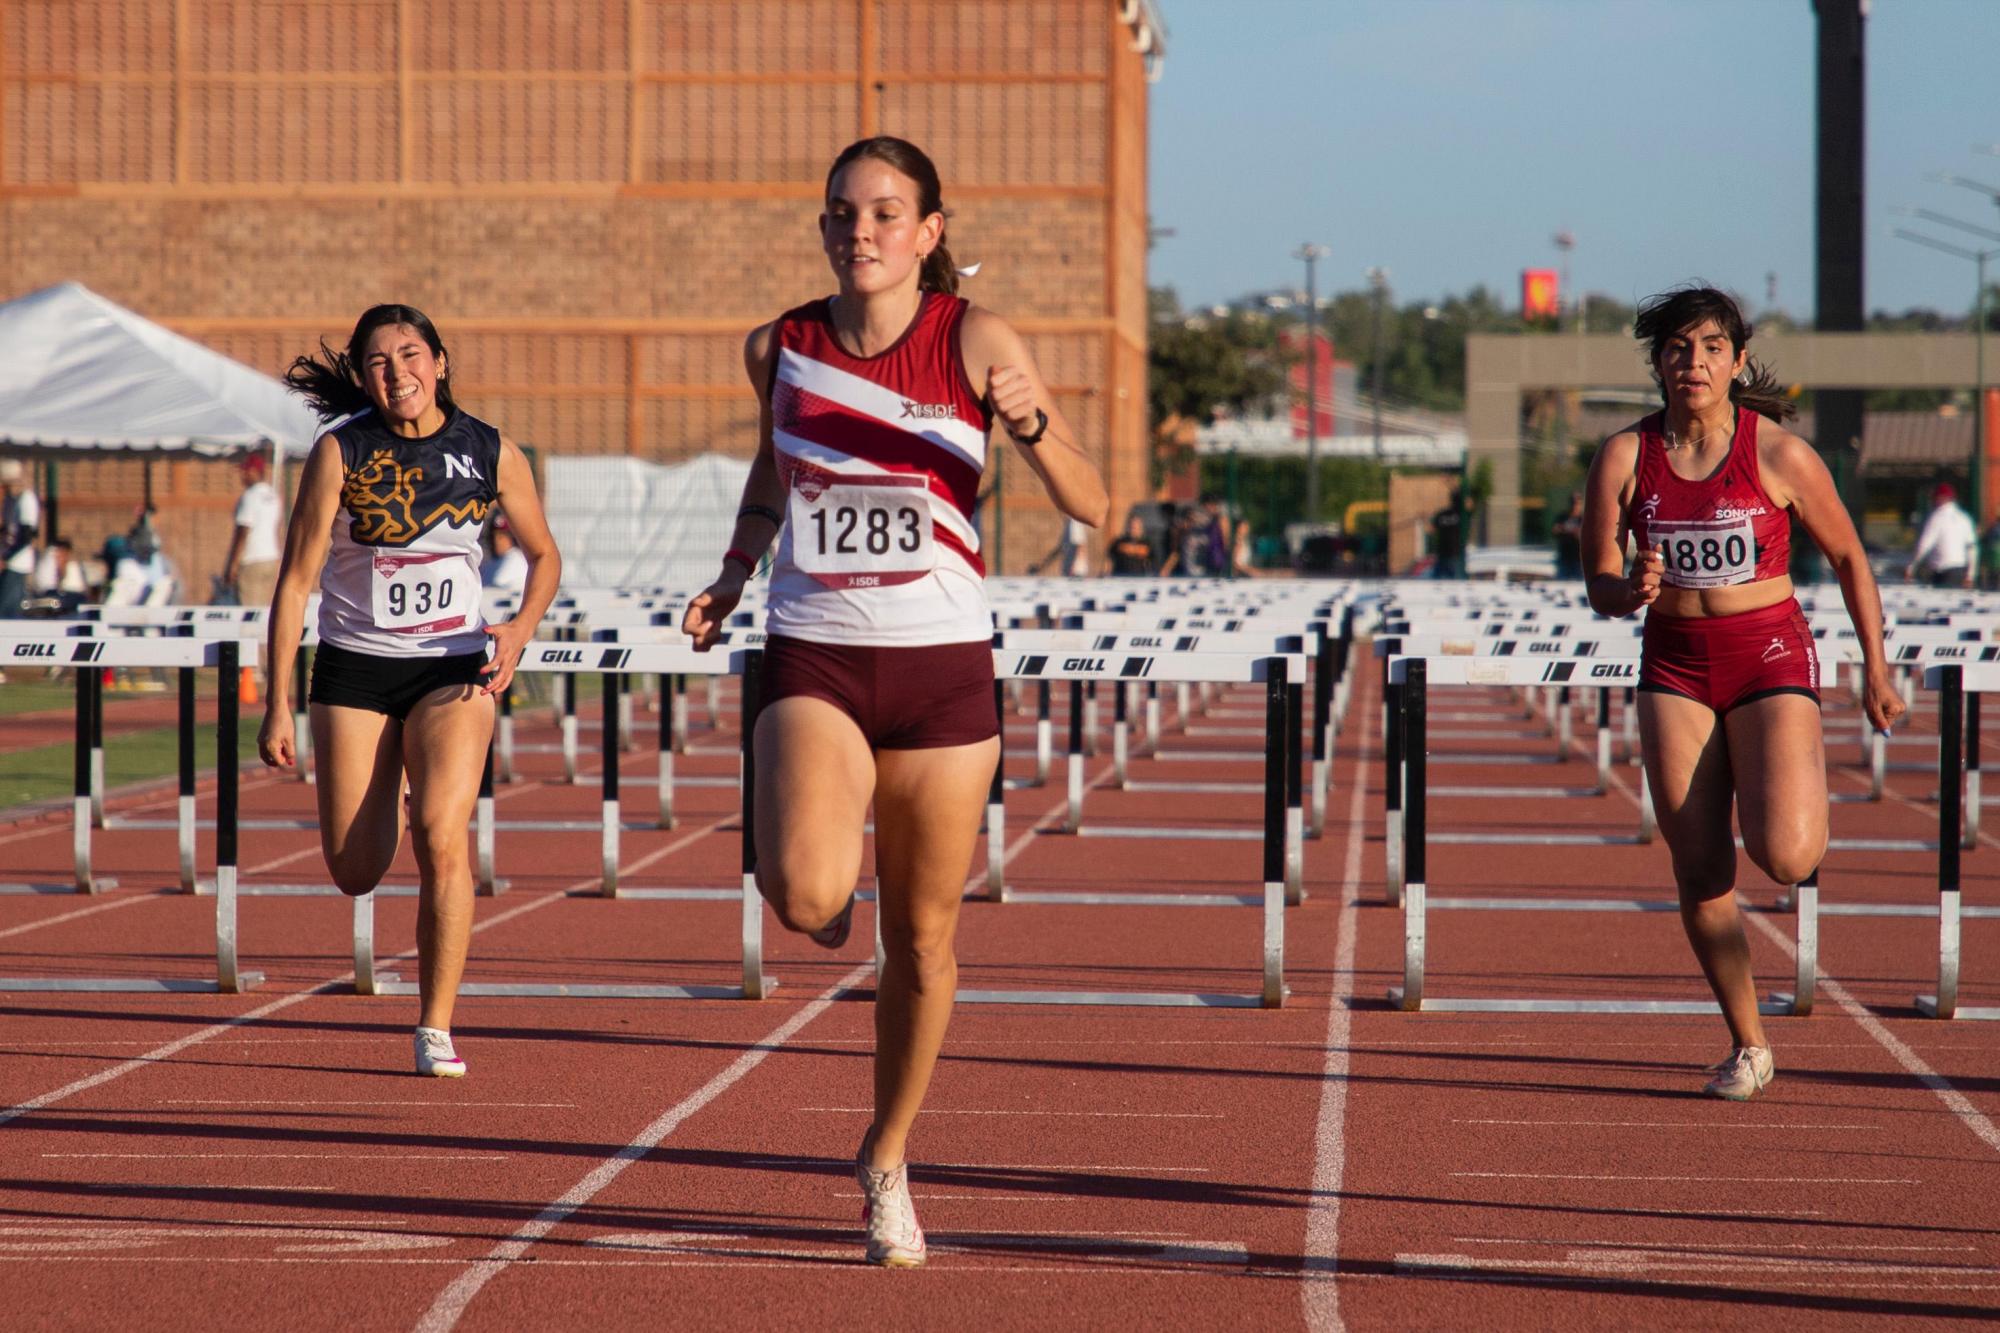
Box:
766;292;992;646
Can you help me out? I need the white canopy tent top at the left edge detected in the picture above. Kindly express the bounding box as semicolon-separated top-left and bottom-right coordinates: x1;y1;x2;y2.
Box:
0;282;320;460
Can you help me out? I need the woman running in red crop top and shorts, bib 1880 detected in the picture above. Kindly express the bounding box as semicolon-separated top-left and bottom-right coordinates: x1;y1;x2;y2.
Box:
1582;286;1904;1101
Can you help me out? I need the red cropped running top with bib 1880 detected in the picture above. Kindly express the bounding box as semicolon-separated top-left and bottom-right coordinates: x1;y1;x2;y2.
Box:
1632;408;1792;588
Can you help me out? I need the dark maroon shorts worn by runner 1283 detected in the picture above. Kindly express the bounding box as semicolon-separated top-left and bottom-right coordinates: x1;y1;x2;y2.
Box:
762;634;1000;751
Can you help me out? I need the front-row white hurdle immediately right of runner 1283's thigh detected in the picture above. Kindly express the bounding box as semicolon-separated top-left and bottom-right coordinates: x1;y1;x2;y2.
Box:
958;648;1298;1009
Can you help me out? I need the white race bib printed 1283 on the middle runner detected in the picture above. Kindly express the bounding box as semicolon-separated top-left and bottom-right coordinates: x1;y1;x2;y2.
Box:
790;474;938;588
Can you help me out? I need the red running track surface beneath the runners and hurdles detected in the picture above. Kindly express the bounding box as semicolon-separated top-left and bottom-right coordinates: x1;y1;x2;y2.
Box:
0;668;2000;1329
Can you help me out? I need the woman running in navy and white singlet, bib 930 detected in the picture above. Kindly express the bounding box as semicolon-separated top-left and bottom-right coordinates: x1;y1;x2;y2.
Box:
258;304;562;1079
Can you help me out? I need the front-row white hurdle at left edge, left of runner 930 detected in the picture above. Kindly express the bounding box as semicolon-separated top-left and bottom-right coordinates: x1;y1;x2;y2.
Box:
0;622;264;995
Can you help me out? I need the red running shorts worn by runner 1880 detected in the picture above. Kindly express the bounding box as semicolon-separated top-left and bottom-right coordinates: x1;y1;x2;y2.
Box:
1638;598;1820;713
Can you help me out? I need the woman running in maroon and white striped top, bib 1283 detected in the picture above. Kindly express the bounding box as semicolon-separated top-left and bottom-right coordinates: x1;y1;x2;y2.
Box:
682;138;1110;1267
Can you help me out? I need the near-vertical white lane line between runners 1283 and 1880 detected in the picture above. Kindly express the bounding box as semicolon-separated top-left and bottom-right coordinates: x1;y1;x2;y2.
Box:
1298;688;1376;1333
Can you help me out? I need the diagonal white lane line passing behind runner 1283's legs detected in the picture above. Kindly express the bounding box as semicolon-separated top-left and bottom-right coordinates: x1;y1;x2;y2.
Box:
416;765;1112;1333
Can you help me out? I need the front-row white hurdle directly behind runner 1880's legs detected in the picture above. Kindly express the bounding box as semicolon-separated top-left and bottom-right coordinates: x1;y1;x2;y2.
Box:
1388;656;1818;1015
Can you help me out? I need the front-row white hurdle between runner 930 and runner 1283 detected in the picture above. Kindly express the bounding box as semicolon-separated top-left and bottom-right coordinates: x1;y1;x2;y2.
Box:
354;642;778;999
